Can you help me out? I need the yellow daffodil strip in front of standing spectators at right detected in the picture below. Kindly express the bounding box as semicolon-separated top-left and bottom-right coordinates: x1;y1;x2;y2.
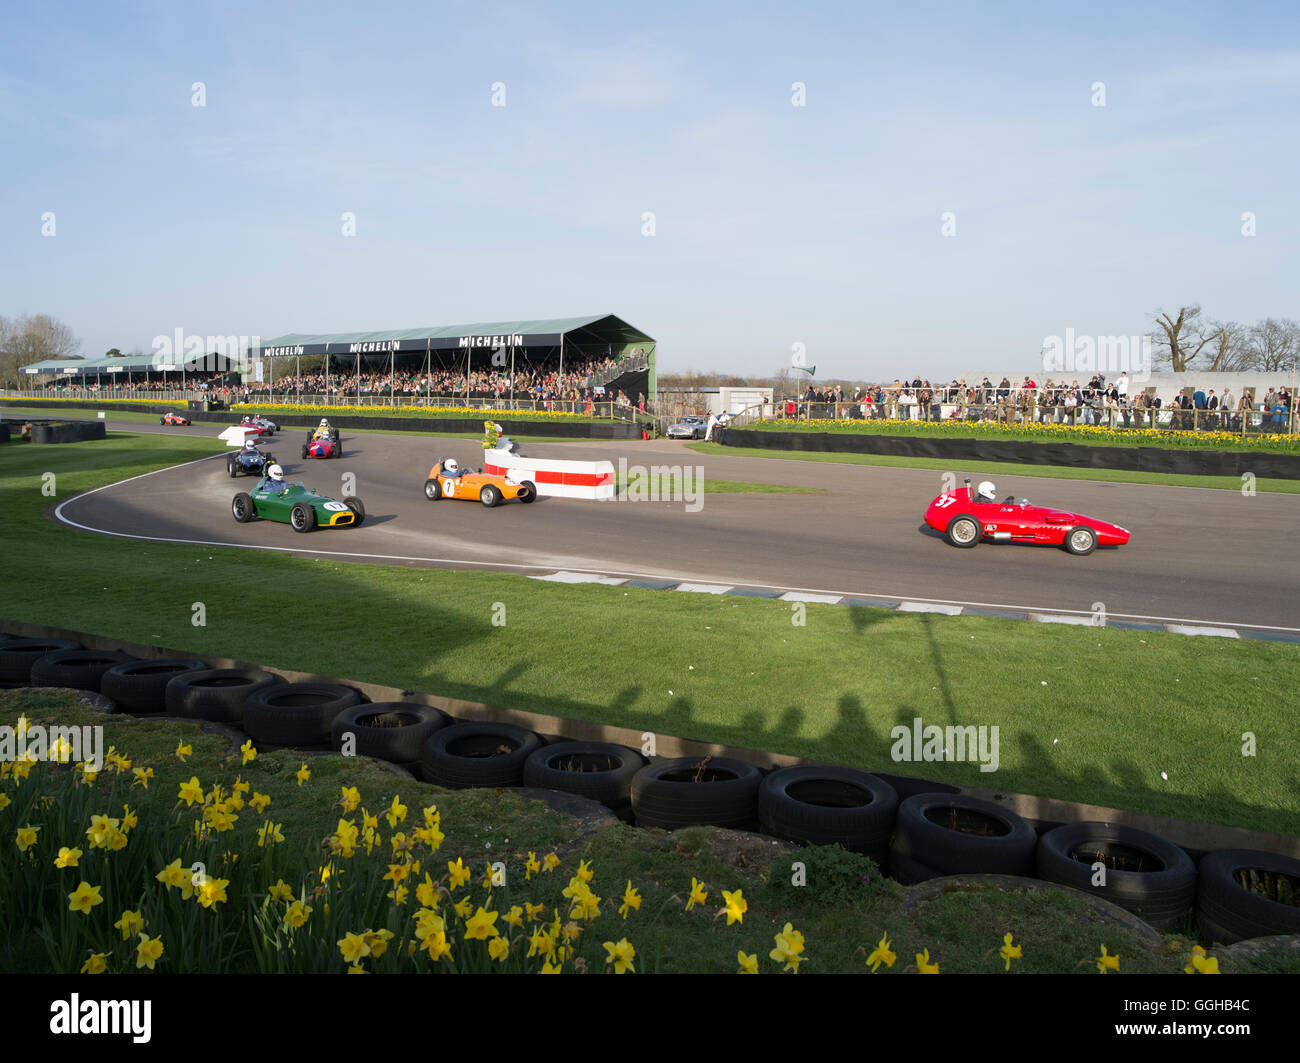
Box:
746;415;1300;454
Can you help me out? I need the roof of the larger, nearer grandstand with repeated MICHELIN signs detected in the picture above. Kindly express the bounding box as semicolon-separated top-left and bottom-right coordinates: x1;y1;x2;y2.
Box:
252;313;654;357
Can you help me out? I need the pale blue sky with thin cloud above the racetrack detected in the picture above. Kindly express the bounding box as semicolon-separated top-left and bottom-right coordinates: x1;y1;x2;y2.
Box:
0;3;1300;379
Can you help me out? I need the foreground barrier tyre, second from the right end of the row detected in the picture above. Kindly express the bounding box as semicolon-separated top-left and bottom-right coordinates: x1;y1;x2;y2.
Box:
1036;823;1196;929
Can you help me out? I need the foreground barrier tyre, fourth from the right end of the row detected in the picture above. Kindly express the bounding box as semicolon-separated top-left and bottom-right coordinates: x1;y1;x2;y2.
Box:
758;764;898;863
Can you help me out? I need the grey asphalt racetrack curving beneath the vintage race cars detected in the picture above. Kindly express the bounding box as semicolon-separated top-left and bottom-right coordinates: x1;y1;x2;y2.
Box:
50;421;1300;632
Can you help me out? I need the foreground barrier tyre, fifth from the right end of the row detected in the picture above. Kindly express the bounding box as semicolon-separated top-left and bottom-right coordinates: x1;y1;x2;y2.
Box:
632;756;762;830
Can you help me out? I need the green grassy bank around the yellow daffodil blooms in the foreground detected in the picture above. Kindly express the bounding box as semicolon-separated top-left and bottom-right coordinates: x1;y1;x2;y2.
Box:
0;691;1300;976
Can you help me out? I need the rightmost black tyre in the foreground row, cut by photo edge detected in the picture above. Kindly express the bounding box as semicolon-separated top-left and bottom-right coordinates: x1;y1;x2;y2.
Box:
1196;849;1300;945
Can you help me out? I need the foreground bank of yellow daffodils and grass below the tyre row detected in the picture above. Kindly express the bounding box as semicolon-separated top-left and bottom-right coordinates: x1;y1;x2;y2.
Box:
0;690;1300;975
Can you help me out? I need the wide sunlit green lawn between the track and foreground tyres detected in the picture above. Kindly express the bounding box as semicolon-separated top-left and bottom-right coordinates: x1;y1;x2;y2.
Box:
0;433;1300;832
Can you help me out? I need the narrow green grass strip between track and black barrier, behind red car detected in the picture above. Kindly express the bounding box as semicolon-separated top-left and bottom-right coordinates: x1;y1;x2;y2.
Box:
686;443;1300;495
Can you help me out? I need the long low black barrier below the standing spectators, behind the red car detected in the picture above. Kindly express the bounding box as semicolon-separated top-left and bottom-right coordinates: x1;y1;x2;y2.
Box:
719;428;1300;480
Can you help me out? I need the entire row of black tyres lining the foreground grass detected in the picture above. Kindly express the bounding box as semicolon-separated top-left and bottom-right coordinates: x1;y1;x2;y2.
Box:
0;637;1300;945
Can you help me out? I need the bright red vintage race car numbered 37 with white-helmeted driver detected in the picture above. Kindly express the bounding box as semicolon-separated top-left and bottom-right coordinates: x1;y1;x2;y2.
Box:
926;480;1128;556
